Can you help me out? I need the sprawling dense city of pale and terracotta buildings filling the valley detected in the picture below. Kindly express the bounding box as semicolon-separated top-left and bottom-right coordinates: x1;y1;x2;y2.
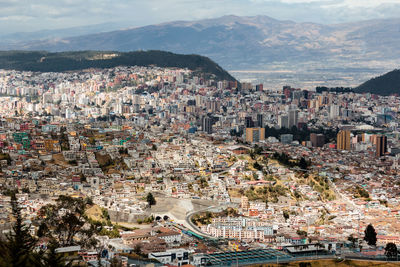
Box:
0;1;400;267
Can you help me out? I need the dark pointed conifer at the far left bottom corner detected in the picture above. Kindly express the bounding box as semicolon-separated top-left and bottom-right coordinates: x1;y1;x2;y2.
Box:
0;192;37;267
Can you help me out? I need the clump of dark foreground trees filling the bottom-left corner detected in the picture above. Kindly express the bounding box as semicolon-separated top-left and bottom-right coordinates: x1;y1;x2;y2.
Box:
0;195;107;267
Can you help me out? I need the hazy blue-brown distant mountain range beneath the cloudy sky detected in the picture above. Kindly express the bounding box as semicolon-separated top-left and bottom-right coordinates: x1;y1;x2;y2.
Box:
0;16;400;70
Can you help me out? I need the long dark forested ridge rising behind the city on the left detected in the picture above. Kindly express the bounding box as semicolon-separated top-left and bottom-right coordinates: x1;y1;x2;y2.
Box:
0;51;236;81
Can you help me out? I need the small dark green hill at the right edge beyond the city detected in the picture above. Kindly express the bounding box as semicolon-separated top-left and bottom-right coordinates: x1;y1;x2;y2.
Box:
355;70;400;95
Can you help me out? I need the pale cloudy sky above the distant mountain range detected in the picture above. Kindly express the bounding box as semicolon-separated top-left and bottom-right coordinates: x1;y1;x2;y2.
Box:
0;0;400;36
